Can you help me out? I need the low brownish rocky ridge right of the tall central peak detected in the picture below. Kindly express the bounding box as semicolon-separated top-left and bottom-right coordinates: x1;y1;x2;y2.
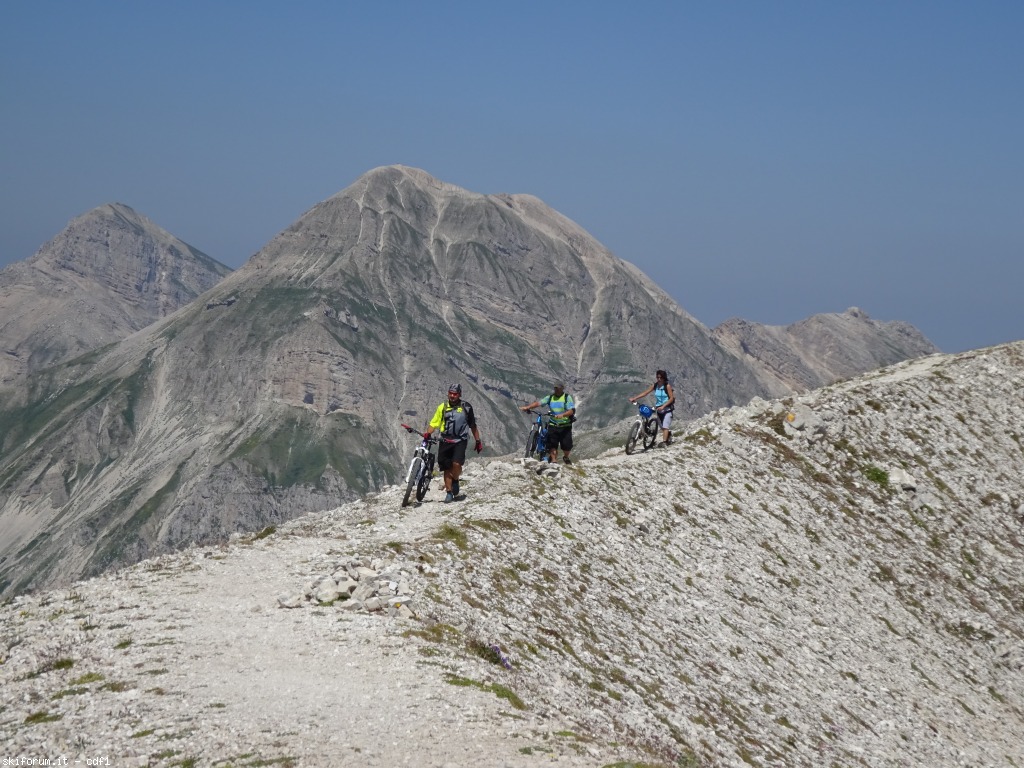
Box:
712;307;939;397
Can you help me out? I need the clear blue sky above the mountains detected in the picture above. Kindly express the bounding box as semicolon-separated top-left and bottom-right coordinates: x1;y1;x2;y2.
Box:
0;0;1024;351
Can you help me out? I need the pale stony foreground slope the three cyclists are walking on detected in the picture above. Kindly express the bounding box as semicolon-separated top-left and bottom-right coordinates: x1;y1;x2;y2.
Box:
0;342;1024;768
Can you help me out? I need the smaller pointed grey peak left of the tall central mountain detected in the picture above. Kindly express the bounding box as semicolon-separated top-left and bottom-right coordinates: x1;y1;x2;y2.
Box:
0;203;230;387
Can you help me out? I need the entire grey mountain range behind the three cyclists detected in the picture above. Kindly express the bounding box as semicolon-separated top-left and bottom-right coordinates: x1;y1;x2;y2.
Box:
0;166;937;594
